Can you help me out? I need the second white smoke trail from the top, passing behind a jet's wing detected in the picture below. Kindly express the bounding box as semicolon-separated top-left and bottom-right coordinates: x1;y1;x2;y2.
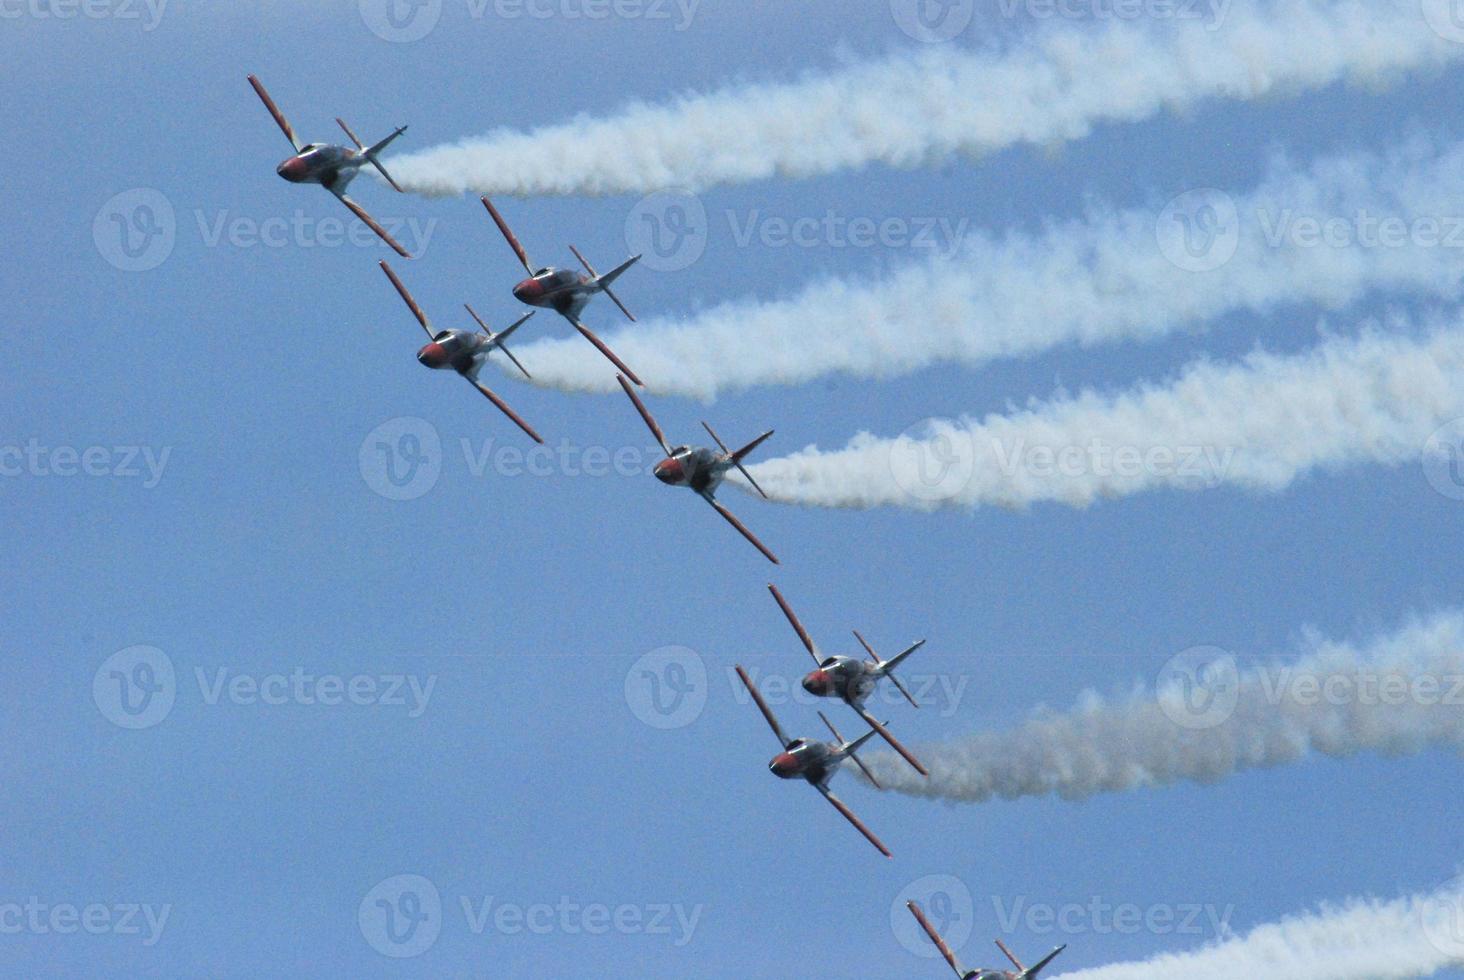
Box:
505;139;1464;400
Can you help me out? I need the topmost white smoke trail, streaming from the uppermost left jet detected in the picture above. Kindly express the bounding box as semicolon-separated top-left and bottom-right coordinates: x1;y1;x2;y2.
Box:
391;0;1461;195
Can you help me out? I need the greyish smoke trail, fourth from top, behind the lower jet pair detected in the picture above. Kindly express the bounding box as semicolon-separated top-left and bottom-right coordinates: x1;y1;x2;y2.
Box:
865;611;1464;802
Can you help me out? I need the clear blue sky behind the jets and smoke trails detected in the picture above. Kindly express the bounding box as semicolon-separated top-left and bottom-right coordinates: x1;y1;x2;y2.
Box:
0;1;1464;977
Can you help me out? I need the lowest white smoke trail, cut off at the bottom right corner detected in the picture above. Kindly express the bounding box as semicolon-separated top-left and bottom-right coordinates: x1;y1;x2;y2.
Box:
1056;886;1464;980
